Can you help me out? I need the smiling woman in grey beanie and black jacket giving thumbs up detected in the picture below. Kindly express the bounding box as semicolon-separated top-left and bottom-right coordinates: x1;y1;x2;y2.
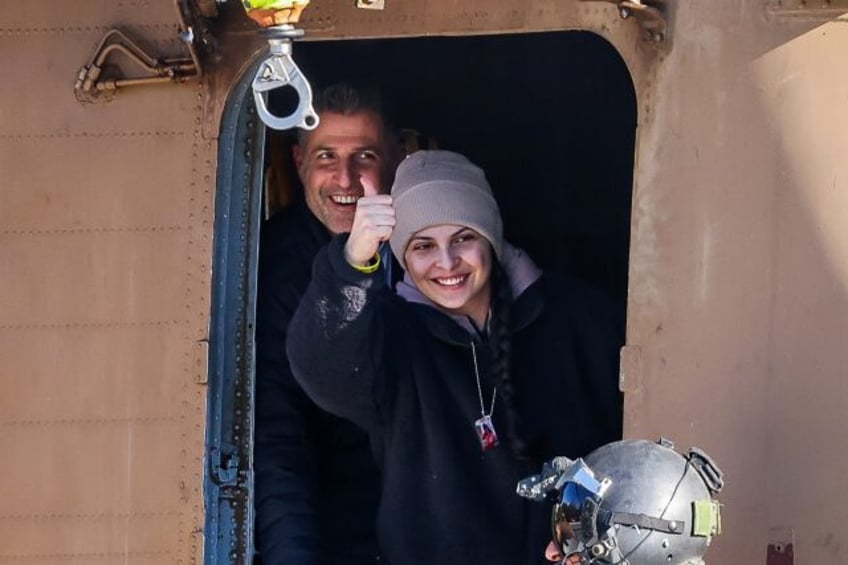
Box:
287;151;621;565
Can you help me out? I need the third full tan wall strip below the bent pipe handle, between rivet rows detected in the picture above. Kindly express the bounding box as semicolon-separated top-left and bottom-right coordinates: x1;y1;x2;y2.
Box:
0;321;190;418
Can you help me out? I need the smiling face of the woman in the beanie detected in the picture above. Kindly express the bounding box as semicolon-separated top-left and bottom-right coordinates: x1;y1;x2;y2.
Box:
403;224;492;327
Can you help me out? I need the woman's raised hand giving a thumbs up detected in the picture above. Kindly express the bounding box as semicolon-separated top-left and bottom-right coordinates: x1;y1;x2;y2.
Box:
345;191;395;267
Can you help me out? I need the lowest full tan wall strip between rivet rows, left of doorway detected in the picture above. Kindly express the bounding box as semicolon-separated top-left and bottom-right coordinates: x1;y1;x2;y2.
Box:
0;415;181;512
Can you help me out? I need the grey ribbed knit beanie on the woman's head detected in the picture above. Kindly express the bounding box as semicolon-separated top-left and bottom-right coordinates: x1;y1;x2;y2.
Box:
389;151;503;269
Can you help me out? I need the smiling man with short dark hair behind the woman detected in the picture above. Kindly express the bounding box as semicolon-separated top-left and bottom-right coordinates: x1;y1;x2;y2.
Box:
254;85;399;565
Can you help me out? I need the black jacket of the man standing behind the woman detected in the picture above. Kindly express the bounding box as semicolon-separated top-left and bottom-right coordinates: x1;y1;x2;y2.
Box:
254;204;380;565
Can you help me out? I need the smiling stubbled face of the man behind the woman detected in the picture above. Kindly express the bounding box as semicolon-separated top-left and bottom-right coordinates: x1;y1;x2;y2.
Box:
294;111;388;234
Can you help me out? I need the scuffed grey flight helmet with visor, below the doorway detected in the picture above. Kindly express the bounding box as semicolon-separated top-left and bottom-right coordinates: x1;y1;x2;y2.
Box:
518;439;724;565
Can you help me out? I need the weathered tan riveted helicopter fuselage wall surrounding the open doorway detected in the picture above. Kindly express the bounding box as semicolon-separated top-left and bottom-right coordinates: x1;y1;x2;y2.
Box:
0;0;848;565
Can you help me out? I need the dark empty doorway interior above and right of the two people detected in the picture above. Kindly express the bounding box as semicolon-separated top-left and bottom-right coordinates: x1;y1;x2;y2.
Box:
268;31;636;302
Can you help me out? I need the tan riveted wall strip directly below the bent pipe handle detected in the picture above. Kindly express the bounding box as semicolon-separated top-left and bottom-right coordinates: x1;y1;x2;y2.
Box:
0;135;195;230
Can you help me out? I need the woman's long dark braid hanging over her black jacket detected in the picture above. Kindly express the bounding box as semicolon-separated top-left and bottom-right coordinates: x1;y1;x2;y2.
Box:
489;261;527;461
